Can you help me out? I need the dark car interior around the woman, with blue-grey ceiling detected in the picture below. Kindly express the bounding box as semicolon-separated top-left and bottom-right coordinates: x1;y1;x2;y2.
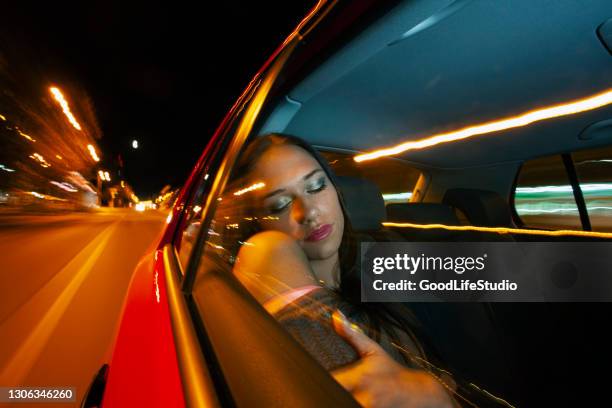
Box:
183;0;612;406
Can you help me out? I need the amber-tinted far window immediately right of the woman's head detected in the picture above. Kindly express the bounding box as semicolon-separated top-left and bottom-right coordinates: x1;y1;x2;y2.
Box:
321;150;421;204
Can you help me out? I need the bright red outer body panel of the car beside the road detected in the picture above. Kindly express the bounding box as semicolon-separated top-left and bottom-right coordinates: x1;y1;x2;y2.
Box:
102;251;185;407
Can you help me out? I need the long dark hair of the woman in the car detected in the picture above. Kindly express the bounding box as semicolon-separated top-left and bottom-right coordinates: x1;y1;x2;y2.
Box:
235;134;432;358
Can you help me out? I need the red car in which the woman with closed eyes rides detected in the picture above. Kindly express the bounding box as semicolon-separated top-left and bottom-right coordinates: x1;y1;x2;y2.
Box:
83;0;612;407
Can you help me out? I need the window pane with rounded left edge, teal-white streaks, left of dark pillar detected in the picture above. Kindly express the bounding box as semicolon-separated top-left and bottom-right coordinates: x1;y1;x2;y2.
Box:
514;156;582;229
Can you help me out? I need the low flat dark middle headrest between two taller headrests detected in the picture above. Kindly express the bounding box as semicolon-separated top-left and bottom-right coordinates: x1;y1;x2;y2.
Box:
387;203;460;225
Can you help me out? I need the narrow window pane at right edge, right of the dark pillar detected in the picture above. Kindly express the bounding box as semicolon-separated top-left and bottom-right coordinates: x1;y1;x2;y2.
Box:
572;146;612;232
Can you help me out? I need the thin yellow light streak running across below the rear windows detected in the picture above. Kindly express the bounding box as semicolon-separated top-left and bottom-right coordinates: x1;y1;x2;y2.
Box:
382;222;612;238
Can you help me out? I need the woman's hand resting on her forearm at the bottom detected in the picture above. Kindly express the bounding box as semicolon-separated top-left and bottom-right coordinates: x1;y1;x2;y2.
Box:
332;311;453;408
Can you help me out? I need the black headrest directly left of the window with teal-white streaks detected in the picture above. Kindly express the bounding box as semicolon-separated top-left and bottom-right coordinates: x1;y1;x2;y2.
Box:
442;188;512;227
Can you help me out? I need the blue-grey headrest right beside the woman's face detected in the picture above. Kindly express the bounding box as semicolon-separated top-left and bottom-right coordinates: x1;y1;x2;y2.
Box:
337;176;385;231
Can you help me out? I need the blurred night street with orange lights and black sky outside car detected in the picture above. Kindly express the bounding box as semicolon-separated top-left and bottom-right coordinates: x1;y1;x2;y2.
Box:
0;1;314;401
